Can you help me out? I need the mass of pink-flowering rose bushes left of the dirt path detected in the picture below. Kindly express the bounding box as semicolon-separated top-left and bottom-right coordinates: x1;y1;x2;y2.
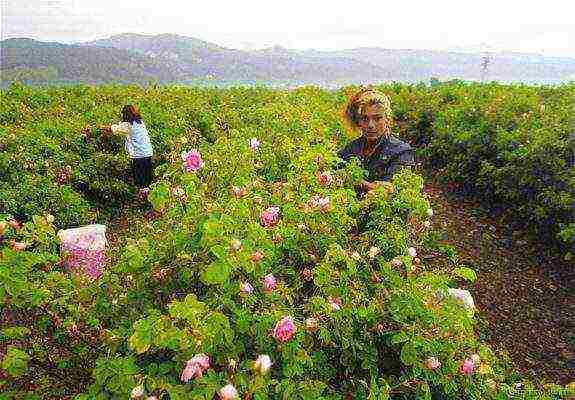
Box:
0;86;568;400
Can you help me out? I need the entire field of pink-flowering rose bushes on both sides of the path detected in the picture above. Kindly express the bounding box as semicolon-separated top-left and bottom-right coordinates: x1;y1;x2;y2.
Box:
0;81;575;400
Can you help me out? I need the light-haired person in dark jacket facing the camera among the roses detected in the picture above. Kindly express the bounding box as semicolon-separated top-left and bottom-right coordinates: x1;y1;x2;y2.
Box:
338;87;415;194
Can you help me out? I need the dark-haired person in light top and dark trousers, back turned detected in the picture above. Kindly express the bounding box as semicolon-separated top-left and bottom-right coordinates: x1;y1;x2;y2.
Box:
100;104;154;200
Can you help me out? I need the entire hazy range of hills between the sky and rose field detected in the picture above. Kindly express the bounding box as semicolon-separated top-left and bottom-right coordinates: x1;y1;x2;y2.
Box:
0;34;575;86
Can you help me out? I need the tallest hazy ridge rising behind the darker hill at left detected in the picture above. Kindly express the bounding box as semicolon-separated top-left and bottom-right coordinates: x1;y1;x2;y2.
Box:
84;34;388;82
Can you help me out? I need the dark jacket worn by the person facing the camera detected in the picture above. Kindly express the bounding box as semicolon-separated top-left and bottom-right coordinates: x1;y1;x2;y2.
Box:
338;136;415;182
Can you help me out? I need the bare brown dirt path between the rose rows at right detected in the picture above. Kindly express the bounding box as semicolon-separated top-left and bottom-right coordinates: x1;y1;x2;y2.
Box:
425;181;575;384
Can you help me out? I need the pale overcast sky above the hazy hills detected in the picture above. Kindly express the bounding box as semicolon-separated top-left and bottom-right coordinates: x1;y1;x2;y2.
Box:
1;0;575;57
